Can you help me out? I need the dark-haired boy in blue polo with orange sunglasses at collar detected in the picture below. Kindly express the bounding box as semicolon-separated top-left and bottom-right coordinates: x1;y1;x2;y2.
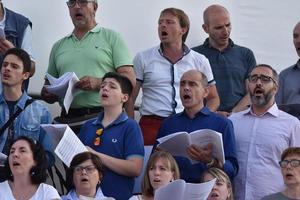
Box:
79;72;144;200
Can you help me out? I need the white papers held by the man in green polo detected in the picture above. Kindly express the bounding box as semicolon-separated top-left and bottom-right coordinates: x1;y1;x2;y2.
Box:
45;72;79;113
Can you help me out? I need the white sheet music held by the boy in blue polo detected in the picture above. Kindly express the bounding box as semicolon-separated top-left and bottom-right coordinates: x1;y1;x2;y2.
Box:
41;124;88;167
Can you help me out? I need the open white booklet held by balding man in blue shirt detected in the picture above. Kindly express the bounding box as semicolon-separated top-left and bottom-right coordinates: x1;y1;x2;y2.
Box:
157;129;225;164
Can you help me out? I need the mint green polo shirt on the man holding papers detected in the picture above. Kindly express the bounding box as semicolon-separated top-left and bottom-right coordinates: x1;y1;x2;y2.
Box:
48;25;132;108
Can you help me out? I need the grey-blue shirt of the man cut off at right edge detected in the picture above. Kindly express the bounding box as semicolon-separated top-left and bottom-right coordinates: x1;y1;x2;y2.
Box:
276;60;300;104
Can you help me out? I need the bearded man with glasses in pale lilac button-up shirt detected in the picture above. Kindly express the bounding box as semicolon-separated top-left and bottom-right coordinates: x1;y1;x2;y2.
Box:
230;64;300;200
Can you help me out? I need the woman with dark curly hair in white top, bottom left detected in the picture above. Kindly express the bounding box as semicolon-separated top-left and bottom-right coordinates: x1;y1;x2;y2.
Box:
0;136;60;200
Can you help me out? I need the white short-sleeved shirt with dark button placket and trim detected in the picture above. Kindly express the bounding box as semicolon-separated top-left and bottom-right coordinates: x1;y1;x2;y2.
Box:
133;46;215;117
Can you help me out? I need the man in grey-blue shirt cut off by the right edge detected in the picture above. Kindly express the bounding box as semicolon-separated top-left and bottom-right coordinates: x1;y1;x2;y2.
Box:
276;21;300;111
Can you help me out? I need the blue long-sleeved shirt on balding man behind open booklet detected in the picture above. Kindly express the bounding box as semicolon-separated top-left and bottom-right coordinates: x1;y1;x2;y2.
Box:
154;107;238;183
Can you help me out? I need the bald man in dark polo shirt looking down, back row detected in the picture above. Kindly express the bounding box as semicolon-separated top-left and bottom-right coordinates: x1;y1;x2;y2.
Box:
193;5;256;116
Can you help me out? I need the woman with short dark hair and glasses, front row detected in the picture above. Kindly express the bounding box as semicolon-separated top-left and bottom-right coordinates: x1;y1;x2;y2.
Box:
61;152;114;200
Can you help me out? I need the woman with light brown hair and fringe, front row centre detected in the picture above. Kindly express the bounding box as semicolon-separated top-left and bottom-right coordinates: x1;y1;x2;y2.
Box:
129;150;180;200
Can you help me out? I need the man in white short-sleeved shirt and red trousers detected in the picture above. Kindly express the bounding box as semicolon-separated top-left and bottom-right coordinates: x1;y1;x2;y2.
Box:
133;8;220;145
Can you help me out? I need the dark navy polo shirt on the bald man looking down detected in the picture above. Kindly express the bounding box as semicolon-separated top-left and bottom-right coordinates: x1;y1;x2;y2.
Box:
193;38;256;112
